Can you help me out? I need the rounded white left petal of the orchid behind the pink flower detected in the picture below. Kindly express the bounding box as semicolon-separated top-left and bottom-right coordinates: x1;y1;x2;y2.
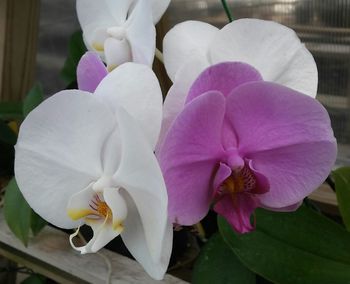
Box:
163;21;218;82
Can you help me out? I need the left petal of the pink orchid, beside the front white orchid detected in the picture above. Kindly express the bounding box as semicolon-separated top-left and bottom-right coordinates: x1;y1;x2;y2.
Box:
158;92;225;225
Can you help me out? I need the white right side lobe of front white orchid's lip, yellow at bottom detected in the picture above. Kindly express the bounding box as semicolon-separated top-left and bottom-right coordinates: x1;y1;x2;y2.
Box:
103;188;128;231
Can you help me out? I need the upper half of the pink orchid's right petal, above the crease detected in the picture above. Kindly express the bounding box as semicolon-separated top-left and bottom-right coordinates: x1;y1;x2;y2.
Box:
226;82;335;156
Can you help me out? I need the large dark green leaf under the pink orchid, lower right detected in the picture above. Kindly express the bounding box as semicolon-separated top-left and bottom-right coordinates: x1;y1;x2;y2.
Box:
218;206;350;284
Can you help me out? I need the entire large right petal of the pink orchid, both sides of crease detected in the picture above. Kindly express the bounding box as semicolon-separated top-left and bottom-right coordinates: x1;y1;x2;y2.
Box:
226;82;336;208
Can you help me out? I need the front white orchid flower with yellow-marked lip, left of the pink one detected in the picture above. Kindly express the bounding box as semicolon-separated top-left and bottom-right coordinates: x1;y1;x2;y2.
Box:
15;63;172;279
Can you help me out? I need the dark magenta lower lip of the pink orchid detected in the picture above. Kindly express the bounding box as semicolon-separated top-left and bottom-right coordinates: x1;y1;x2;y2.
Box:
214;193;258;234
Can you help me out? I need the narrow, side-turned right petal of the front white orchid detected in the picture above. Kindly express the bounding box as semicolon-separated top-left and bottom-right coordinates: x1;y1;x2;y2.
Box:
113;109;168;260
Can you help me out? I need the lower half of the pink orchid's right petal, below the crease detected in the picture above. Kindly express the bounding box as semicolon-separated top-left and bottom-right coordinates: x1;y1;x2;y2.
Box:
249;141;337;209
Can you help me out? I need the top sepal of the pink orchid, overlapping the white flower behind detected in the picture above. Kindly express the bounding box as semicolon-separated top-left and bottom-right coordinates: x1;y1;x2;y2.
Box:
186;62;262;103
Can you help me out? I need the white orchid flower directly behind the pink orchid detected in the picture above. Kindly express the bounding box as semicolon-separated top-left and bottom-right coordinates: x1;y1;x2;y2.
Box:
160;19;318;150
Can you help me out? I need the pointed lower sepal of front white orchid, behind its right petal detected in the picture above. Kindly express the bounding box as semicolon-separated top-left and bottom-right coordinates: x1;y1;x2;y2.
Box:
121;190;173;280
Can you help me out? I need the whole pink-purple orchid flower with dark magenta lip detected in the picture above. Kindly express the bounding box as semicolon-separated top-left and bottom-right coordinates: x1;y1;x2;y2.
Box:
158;62;337;233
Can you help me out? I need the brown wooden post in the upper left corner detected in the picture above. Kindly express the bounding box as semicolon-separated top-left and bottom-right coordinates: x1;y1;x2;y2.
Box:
0;0;40;102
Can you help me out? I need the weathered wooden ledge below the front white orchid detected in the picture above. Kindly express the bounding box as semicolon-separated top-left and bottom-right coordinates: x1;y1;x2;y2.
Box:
0;211;187;284
